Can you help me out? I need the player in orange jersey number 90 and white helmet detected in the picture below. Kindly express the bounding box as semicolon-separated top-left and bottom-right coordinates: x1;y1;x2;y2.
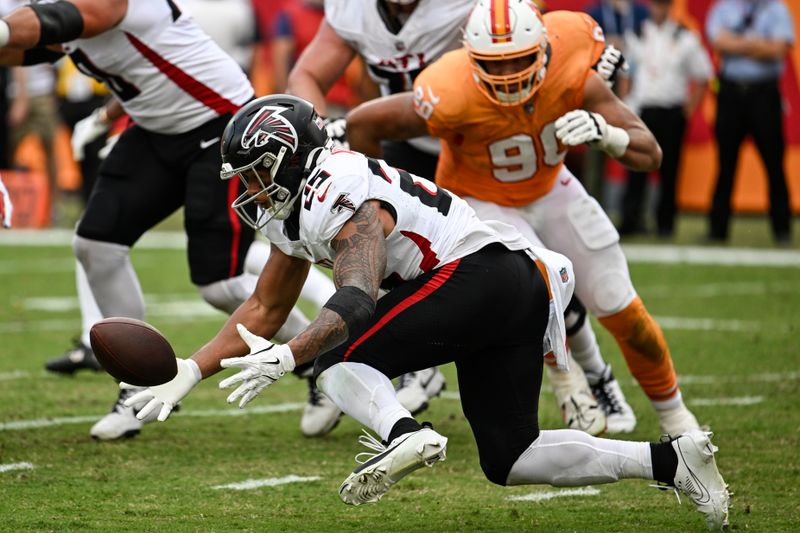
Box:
348;0;698;436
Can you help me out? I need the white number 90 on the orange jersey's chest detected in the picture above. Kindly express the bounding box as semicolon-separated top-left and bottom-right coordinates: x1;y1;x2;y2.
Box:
489;122;567;183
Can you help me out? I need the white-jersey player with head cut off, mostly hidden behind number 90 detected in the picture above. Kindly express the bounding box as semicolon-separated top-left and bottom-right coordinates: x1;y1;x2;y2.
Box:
287;0;636;434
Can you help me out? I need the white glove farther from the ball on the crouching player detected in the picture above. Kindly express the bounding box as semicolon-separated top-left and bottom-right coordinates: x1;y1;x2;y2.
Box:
219;324;295;408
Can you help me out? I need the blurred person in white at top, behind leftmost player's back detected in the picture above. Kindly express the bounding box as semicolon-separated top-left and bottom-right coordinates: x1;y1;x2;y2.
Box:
181;0;258;74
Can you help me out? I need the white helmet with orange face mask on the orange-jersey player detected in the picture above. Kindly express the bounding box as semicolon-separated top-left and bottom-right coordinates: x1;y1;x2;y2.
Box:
464;0;547;106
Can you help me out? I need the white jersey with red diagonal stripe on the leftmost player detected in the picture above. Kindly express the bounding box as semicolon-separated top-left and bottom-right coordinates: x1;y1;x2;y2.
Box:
64;0;253;134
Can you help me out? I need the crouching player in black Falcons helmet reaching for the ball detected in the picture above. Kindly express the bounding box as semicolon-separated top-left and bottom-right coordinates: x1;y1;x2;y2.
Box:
122;95;728;530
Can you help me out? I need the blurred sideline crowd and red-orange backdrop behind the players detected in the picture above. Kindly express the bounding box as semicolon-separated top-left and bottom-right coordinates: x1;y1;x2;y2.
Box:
0;0;800;246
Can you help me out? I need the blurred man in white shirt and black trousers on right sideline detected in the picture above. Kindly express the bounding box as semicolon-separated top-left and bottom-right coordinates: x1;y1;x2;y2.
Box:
619;0;713;237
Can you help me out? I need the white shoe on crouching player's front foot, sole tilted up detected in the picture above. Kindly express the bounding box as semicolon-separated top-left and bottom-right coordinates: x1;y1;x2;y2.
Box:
339;427;447;505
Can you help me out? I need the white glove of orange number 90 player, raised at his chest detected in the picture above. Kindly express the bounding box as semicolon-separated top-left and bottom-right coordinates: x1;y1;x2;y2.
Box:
555;109;630;157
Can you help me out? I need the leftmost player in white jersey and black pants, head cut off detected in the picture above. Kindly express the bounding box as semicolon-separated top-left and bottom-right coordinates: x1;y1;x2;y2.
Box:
0;0;337;440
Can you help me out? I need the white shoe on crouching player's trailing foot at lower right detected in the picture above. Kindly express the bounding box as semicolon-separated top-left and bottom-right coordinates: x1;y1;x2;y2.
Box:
672;429;730;531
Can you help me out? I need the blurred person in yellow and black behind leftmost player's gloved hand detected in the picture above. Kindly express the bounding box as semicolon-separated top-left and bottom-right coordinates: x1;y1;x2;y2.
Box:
56;58;108;204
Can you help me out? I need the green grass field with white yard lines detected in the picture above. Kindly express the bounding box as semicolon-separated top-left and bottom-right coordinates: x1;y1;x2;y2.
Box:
0;218;800;532
